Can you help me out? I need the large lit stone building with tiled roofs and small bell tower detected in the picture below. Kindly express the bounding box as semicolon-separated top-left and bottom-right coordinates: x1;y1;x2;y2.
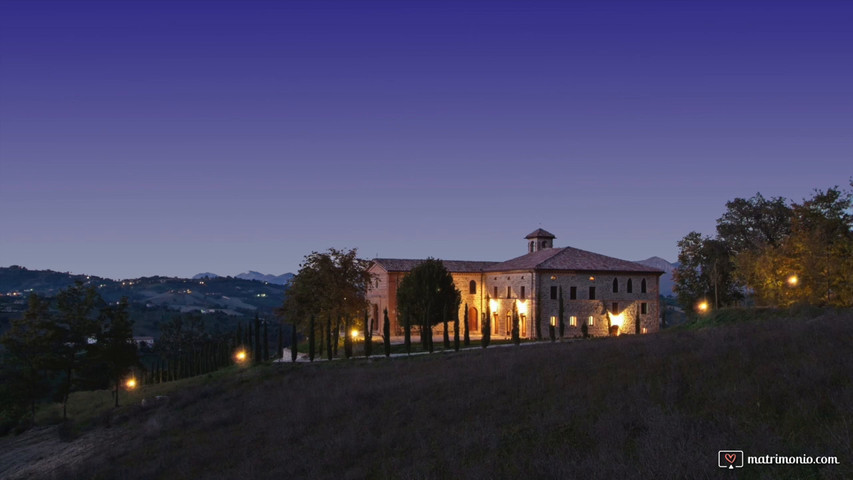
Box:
367;228;664;338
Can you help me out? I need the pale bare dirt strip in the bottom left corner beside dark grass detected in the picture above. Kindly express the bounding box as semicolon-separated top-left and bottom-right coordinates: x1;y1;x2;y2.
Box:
0;425;121;480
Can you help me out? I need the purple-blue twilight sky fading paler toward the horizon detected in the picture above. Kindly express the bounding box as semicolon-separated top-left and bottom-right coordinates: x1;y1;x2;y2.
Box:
0;0;853;278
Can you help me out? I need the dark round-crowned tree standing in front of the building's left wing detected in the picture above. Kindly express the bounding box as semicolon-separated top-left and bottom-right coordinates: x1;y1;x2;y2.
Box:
397;258;462;351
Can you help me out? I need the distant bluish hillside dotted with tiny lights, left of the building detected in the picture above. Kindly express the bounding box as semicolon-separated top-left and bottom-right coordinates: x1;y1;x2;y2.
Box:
0;266;287;336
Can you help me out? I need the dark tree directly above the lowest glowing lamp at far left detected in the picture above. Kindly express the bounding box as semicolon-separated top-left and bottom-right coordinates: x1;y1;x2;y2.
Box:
97;297;139;407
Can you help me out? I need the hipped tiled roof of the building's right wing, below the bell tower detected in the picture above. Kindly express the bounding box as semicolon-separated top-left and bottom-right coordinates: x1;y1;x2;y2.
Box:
486;247;663;274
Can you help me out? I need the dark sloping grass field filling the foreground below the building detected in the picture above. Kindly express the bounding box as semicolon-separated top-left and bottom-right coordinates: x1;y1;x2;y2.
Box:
13;311;853;479
